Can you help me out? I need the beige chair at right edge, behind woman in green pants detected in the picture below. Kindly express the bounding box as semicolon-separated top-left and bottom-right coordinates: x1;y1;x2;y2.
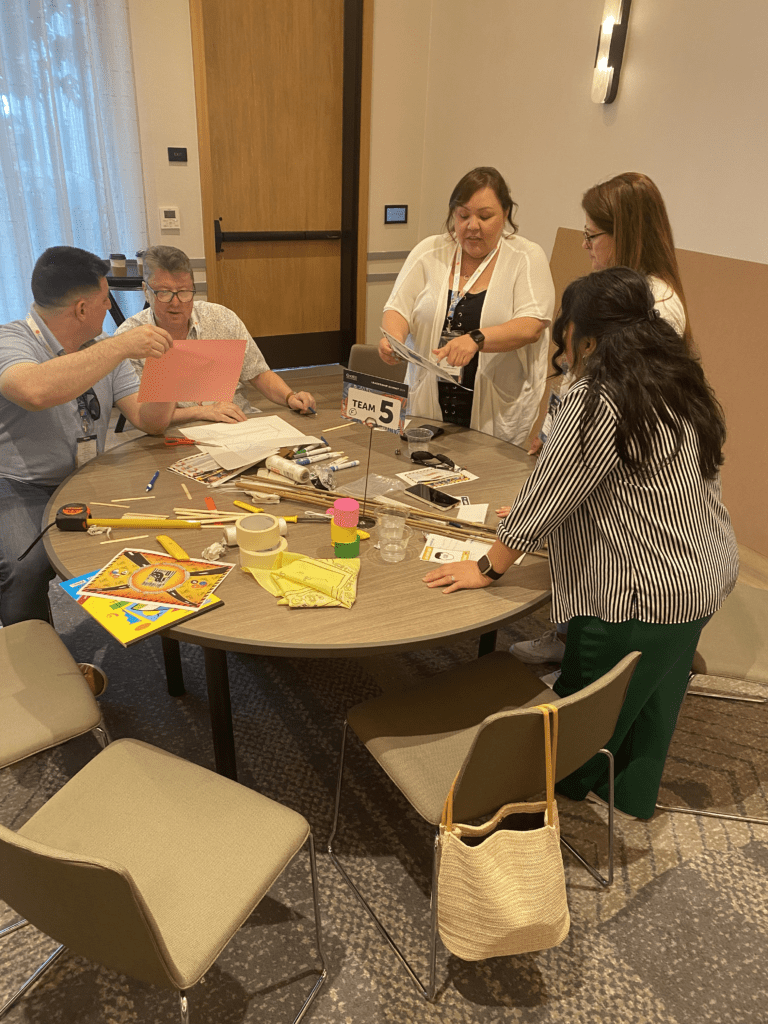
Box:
656;583;768;824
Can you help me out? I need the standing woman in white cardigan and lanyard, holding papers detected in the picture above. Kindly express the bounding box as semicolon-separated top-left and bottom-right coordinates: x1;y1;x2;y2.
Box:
379;167;555;444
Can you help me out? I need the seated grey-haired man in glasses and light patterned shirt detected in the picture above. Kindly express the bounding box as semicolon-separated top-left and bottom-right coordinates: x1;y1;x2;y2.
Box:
115;246;314;423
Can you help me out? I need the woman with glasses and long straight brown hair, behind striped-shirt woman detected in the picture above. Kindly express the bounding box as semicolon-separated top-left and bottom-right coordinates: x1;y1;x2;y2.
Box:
512;171;692;665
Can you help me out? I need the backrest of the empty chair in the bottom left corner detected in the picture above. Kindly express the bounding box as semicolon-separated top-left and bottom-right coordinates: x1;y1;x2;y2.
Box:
0;825;181;989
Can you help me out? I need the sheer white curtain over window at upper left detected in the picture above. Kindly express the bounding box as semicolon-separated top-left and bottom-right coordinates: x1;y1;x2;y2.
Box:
0;0;145;323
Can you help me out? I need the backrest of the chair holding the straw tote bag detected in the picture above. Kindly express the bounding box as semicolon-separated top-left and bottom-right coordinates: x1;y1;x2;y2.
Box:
454;651;640;821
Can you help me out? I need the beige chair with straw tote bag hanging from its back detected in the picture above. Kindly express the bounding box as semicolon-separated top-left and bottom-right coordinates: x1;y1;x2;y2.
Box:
328;651;640;1000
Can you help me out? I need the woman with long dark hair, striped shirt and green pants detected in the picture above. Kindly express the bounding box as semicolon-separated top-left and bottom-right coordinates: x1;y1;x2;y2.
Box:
425;267;738;818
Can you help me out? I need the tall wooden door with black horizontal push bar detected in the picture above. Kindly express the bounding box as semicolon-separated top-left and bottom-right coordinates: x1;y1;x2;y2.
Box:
190;0;366;368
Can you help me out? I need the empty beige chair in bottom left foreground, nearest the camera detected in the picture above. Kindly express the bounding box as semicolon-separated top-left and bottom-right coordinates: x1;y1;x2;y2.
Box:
0;739;327;1024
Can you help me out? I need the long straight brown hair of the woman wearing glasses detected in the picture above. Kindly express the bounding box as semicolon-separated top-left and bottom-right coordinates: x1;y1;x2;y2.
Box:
582;171;692;347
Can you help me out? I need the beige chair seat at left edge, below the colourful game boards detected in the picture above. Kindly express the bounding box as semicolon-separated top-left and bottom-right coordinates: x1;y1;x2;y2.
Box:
0;618;109;768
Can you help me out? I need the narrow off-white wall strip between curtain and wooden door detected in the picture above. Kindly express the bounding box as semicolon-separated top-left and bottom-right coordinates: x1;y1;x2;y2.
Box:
128;0;205;259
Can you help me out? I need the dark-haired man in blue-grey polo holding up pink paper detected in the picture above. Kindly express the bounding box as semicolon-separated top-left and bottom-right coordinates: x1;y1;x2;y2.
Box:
0;246;175;626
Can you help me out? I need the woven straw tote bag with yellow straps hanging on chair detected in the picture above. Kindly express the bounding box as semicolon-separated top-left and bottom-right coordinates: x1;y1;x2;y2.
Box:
437;705;570;961
